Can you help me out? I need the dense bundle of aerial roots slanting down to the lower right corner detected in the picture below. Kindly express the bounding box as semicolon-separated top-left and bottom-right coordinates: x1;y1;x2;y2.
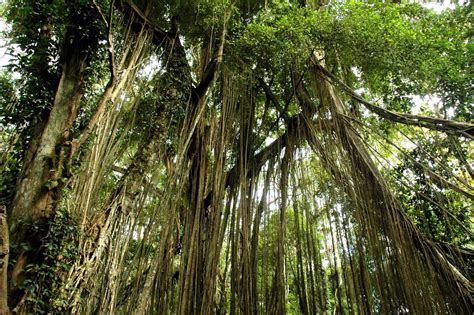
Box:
305;65;472;312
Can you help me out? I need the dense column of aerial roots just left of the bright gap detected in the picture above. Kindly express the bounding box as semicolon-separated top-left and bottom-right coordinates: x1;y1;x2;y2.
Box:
121;68;236;314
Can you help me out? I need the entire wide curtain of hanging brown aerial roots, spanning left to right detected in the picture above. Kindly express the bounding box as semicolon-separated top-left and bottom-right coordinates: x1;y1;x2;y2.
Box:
59;51;469;314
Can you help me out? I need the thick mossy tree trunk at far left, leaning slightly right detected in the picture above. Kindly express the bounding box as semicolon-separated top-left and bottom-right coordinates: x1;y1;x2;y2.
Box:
9;9;95;312
